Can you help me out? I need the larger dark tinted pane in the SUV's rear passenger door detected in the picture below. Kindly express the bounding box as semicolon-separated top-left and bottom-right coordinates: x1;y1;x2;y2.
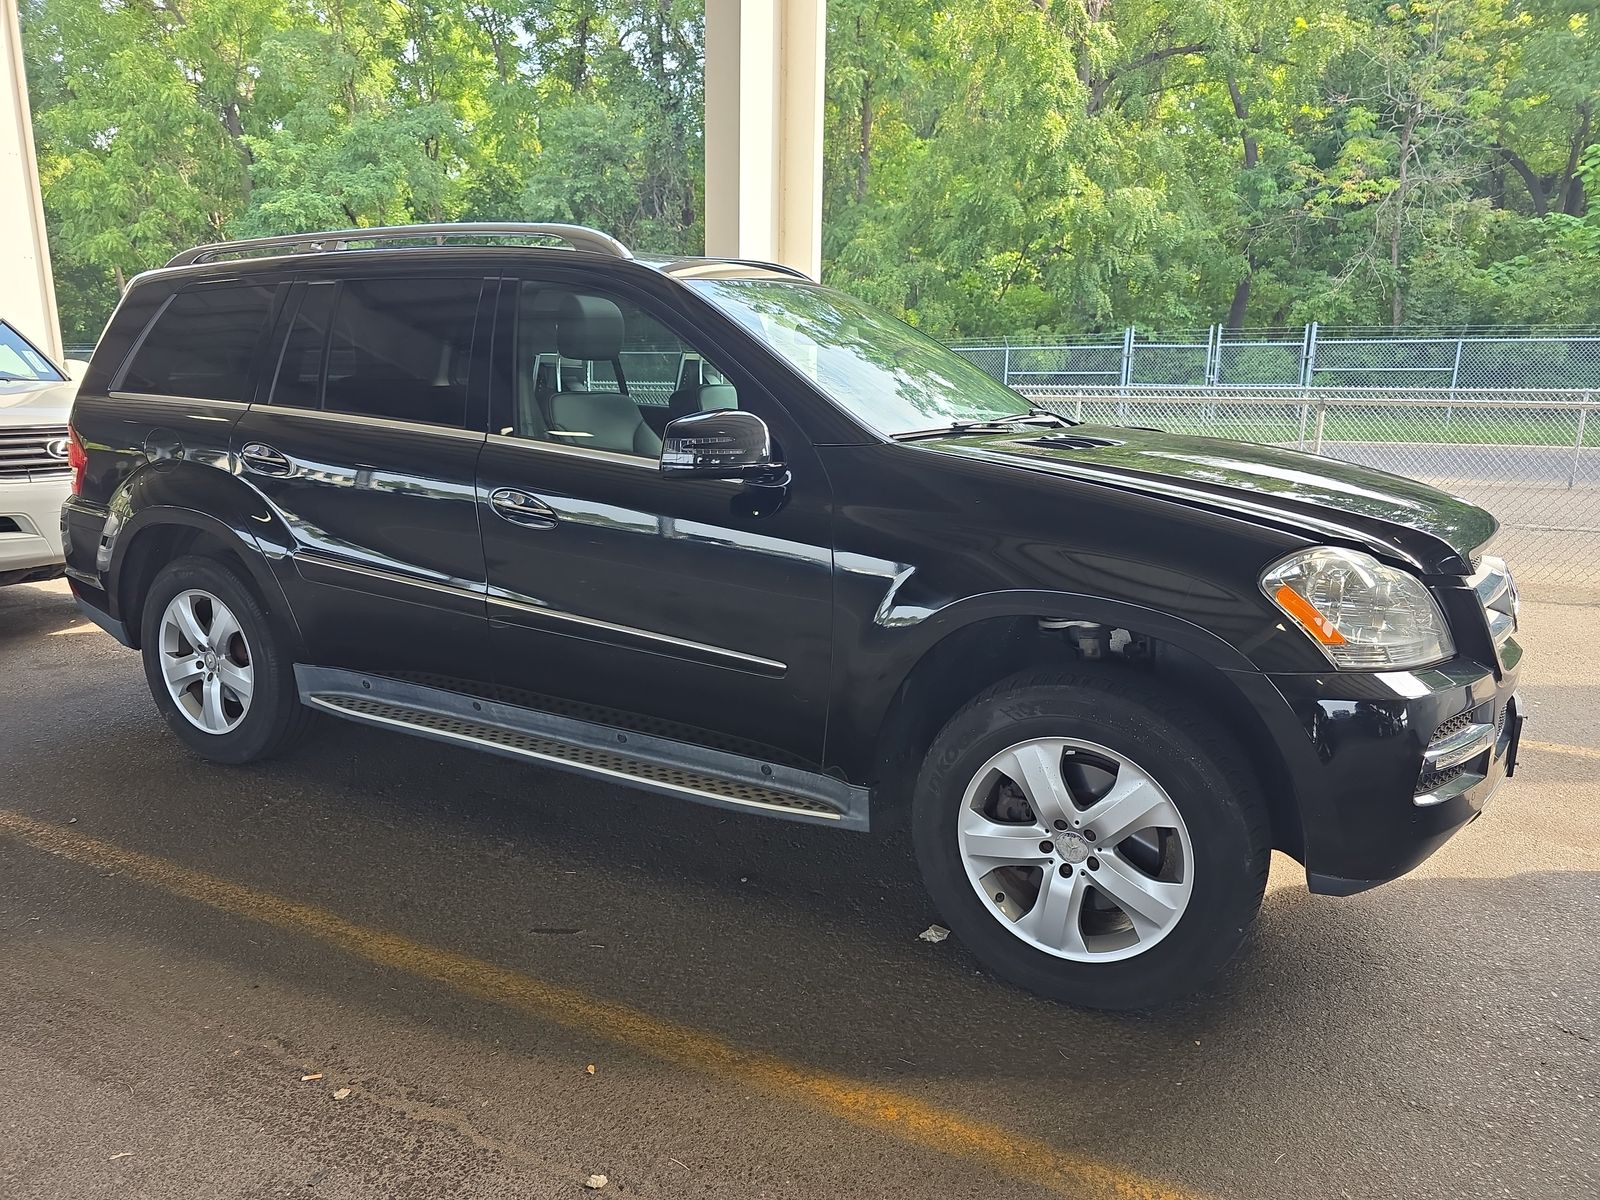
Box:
322;278;482;426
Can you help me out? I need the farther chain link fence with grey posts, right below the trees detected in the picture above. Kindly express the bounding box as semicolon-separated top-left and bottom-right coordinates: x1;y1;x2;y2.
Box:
955;323;1600;392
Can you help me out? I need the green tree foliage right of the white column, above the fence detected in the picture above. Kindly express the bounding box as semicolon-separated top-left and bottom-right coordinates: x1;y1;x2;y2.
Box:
824;0;1600;336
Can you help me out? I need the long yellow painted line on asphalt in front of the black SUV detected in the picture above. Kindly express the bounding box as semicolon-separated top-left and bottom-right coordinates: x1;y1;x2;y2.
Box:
0;808;1194;1200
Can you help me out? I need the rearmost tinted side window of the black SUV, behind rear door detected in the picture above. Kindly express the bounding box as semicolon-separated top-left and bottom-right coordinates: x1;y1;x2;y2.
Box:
122;283;277;402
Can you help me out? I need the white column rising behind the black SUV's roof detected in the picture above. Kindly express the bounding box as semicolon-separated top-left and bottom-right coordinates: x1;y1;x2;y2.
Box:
706;0;827;278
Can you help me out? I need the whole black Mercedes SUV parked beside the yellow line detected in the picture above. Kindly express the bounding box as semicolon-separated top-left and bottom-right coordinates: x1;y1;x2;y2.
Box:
62;226;1522;1006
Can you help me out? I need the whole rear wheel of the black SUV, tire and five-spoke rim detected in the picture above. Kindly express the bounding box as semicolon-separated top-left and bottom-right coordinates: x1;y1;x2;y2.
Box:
141;555;310;763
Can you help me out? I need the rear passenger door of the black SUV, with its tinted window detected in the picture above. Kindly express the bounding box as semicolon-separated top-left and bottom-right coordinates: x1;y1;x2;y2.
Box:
232;274;498;686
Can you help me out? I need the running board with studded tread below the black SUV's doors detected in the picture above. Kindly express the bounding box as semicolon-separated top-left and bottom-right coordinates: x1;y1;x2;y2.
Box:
294;664;867;830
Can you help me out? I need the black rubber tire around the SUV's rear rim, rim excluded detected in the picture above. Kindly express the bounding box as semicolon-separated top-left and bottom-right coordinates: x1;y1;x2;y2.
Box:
139;555;312;763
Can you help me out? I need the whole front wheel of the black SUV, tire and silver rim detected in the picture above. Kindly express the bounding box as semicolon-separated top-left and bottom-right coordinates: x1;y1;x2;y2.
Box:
912;670;1270;1008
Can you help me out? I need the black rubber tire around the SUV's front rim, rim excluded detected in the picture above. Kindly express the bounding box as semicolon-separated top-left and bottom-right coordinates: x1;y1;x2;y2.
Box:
912;667;1272;1010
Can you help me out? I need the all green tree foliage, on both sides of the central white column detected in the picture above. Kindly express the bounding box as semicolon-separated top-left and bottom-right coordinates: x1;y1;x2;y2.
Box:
22;0;1600;339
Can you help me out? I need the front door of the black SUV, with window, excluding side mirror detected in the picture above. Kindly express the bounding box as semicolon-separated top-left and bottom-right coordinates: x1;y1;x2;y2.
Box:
478;280;834;766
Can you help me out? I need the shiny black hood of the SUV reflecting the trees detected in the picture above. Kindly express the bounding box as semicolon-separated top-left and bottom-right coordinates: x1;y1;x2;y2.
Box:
917;426;1499;574
